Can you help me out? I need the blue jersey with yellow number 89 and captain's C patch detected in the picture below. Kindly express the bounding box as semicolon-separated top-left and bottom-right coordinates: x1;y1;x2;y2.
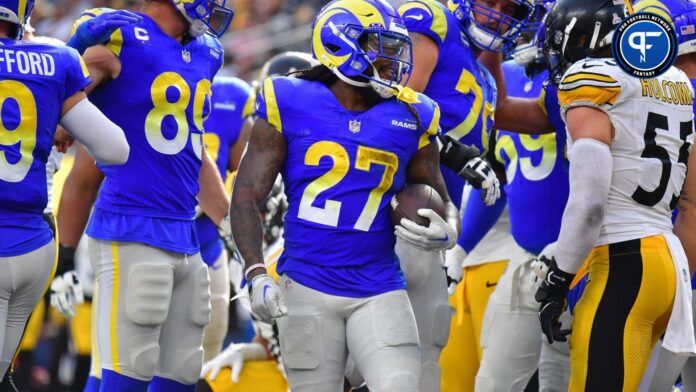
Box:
78;9;223;254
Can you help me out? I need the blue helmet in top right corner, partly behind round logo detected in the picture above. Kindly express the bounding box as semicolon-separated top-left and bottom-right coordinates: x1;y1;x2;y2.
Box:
644;0;696;56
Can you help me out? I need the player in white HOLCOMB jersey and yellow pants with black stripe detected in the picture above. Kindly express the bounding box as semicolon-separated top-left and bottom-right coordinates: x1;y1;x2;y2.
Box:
536;0;696;391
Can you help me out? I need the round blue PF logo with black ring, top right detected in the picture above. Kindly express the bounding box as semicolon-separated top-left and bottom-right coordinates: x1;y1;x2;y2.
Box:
612;12;679;79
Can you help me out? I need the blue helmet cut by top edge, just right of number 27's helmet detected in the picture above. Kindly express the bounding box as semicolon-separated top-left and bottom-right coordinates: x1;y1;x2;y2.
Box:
447;0;534;52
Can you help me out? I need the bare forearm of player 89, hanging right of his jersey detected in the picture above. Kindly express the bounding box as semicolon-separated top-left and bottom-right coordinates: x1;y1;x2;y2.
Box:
198;149;230;225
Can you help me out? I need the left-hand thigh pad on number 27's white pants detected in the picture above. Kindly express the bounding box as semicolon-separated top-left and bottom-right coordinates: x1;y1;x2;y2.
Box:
278;315;322;370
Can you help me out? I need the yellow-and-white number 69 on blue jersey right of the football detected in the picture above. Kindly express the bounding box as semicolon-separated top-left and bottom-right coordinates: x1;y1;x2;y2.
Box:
495;133;558;183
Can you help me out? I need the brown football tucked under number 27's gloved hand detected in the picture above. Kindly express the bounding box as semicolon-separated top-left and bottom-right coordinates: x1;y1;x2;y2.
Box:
391;184;445;226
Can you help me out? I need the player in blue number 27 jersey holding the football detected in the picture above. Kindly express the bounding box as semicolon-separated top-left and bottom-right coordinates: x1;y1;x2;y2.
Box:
231;0;458;391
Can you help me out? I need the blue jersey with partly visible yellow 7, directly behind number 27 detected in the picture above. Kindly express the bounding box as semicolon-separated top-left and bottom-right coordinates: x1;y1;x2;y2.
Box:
399;0;497;207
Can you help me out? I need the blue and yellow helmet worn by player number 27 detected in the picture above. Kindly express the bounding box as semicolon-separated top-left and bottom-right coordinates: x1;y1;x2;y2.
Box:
312;0;413;98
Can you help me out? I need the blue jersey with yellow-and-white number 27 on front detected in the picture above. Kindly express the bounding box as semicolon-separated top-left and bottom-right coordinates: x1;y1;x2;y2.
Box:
256;77;439;297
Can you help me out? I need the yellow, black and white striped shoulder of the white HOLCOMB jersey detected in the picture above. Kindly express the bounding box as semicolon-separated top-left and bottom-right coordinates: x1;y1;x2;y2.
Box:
558;59;628;113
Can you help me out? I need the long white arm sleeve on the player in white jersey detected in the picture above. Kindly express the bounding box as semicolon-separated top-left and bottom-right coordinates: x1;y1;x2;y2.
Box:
555;138;613;274
